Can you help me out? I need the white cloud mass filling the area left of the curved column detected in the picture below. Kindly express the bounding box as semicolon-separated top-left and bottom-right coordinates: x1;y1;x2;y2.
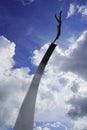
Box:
0;36;31;129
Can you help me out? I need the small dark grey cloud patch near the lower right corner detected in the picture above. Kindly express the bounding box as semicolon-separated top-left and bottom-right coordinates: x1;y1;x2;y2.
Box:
68;96;87;119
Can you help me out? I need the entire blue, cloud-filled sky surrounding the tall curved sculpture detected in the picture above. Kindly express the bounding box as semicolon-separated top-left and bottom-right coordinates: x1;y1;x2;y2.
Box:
0;0;87;130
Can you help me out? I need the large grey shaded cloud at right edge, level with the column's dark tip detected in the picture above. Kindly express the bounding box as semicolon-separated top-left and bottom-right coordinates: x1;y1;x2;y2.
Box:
60;31;87;80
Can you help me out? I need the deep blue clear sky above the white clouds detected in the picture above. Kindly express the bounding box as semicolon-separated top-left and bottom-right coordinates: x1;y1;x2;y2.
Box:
0;0;86;71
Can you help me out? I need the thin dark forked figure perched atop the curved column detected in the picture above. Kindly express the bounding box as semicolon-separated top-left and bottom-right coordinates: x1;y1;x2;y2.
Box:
53;11;62;43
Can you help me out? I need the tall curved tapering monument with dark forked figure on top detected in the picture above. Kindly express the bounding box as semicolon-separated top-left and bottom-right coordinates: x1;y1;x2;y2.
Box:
14;11;62;130
